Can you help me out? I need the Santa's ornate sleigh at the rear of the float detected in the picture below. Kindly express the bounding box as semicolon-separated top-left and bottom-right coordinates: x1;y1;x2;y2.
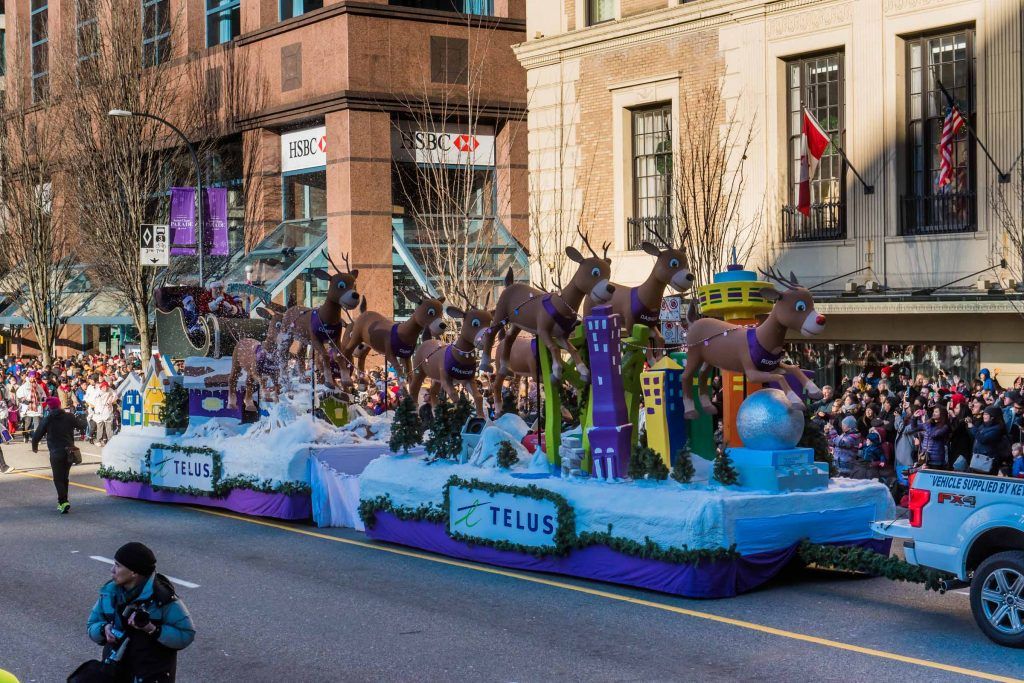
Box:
154;287;267;358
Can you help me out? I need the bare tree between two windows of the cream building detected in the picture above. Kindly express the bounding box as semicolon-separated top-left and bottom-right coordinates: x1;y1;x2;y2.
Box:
667;82;763;287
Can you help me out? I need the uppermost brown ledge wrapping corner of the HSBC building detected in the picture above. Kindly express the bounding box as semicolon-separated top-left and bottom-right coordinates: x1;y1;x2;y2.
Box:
236;0;526;45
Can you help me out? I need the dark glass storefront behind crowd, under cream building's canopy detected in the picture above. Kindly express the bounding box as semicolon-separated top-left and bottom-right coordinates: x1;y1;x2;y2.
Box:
786;342;980;386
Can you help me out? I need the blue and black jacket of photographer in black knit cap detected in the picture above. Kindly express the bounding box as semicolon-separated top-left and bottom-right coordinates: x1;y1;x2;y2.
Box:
88;573;196;680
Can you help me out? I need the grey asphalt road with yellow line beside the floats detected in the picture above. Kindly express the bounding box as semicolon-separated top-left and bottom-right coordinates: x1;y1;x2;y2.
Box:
0;446;1024;683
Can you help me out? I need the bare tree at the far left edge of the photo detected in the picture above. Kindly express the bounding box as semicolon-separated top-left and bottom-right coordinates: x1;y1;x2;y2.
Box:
0;105;76;367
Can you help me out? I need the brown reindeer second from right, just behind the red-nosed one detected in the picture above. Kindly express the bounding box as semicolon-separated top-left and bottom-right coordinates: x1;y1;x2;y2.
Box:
583;237;693;362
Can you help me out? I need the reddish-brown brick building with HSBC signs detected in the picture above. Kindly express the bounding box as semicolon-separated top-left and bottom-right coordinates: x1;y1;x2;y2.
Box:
0;0;527;353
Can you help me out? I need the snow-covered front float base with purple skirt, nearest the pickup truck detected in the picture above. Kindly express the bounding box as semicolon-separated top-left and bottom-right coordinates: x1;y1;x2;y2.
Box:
359;456;895;598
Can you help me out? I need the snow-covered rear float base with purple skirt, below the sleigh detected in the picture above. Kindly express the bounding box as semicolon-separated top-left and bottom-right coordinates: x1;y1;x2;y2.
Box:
99;407;390;519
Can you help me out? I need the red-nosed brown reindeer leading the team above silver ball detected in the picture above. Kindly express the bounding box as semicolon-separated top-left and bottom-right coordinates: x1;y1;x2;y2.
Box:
682;268;825;420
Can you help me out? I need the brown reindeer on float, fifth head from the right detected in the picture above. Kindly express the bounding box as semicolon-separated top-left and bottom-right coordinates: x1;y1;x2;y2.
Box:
341;288;446;385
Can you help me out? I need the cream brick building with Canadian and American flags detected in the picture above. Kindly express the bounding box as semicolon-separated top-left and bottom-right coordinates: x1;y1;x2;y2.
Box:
516;0;1024;382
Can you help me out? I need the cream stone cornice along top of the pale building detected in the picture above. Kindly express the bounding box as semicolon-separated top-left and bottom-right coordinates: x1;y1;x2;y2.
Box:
513;0;847;69
